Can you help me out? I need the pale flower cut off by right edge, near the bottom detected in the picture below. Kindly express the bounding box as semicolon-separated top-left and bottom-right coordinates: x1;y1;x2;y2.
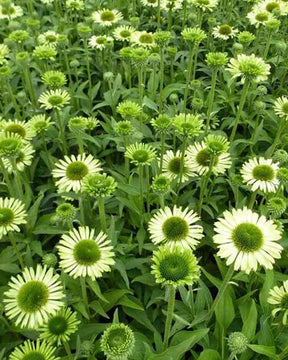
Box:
267;280;288;325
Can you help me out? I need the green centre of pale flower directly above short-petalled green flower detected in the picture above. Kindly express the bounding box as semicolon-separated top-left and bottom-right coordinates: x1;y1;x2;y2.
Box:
162;216;189;241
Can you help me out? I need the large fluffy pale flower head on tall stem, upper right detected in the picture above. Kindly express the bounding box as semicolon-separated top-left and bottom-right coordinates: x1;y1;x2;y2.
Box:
228;54;270;83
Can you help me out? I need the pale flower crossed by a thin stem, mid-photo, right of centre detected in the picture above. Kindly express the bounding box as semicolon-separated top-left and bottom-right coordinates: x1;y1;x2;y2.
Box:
162;150;195;182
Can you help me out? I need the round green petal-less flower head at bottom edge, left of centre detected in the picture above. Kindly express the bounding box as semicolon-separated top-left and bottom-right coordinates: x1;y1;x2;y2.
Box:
100;324;135;360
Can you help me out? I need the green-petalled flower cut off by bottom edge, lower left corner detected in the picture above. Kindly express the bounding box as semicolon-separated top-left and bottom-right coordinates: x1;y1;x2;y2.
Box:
9;340;60;360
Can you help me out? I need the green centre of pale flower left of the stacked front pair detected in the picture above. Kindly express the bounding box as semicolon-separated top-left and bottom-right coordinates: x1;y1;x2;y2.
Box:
73;239;101;266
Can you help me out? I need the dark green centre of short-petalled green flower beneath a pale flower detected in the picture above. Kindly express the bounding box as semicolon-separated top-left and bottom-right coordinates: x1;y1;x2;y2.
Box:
159;254;189;281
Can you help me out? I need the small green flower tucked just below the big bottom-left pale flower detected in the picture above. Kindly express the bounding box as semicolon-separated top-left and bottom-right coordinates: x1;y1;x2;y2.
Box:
39;308;80;346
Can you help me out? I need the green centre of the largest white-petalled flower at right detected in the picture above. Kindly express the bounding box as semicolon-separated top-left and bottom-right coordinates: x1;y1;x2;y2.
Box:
232;223;263;252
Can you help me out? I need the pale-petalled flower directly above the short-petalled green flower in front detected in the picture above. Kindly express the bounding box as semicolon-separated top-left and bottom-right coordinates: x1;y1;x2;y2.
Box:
148;206;203;250
